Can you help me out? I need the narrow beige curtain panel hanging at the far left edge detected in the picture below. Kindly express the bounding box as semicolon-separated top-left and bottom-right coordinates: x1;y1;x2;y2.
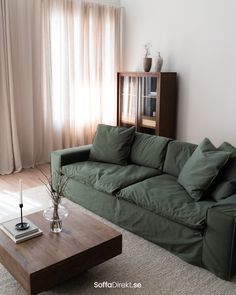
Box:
0;0;22;173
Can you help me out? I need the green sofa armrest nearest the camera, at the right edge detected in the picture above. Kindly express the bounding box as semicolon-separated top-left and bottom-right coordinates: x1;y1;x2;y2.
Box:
202;194;236;280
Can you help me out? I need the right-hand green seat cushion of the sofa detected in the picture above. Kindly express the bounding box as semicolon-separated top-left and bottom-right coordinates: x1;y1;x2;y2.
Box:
117;174;216;229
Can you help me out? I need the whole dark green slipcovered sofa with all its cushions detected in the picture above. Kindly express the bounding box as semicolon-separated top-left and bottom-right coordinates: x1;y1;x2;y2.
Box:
51;125;236;280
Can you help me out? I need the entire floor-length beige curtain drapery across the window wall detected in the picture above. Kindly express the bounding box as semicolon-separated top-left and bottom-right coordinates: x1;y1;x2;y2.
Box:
0;0;120;174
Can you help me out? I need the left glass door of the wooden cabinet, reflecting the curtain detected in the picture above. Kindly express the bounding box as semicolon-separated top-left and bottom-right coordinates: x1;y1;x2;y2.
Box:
119;76;138;126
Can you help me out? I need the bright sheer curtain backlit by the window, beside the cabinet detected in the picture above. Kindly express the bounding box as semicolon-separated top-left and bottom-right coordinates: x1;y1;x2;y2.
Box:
43;0;120;148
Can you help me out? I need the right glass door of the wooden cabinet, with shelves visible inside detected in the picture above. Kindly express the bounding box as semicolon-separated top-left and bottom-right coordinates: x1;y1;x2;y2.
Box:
138;77;158;129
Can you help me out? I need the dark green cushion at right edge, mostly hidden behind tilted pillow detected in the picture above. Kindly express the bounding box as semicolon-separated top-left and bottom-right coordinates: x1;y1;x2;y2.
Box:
208;142;236;201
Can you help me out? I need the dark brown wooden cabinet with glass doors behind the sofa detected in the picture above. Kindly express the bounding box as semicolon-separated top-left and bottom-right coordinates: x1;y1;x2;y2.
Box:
117;72;177;138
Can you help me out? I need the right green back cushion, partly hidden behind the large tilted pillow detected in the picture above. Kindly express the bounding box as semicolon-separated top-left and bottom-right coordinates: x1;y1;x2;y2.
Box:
163;140;197;177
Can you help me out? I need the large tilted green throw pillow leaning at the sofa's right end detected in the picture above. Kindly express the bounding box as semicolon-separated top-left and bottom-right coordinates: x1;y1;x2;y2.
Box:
178;138;231;201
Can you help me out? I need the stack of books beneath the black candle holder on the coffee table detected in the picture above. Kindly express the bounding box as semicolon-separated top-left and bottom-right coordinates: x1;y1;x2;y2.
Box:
0;218;43;244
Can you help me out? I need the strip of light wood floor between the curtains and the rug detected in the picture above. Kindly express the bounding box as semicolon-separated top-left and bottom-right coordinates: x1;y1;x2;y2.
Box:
0;164;50;192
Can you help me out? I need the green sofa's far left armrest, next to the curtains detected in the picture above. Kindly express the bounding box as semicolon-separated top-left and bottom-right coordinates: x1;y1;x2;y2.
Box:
51;144;92;176
